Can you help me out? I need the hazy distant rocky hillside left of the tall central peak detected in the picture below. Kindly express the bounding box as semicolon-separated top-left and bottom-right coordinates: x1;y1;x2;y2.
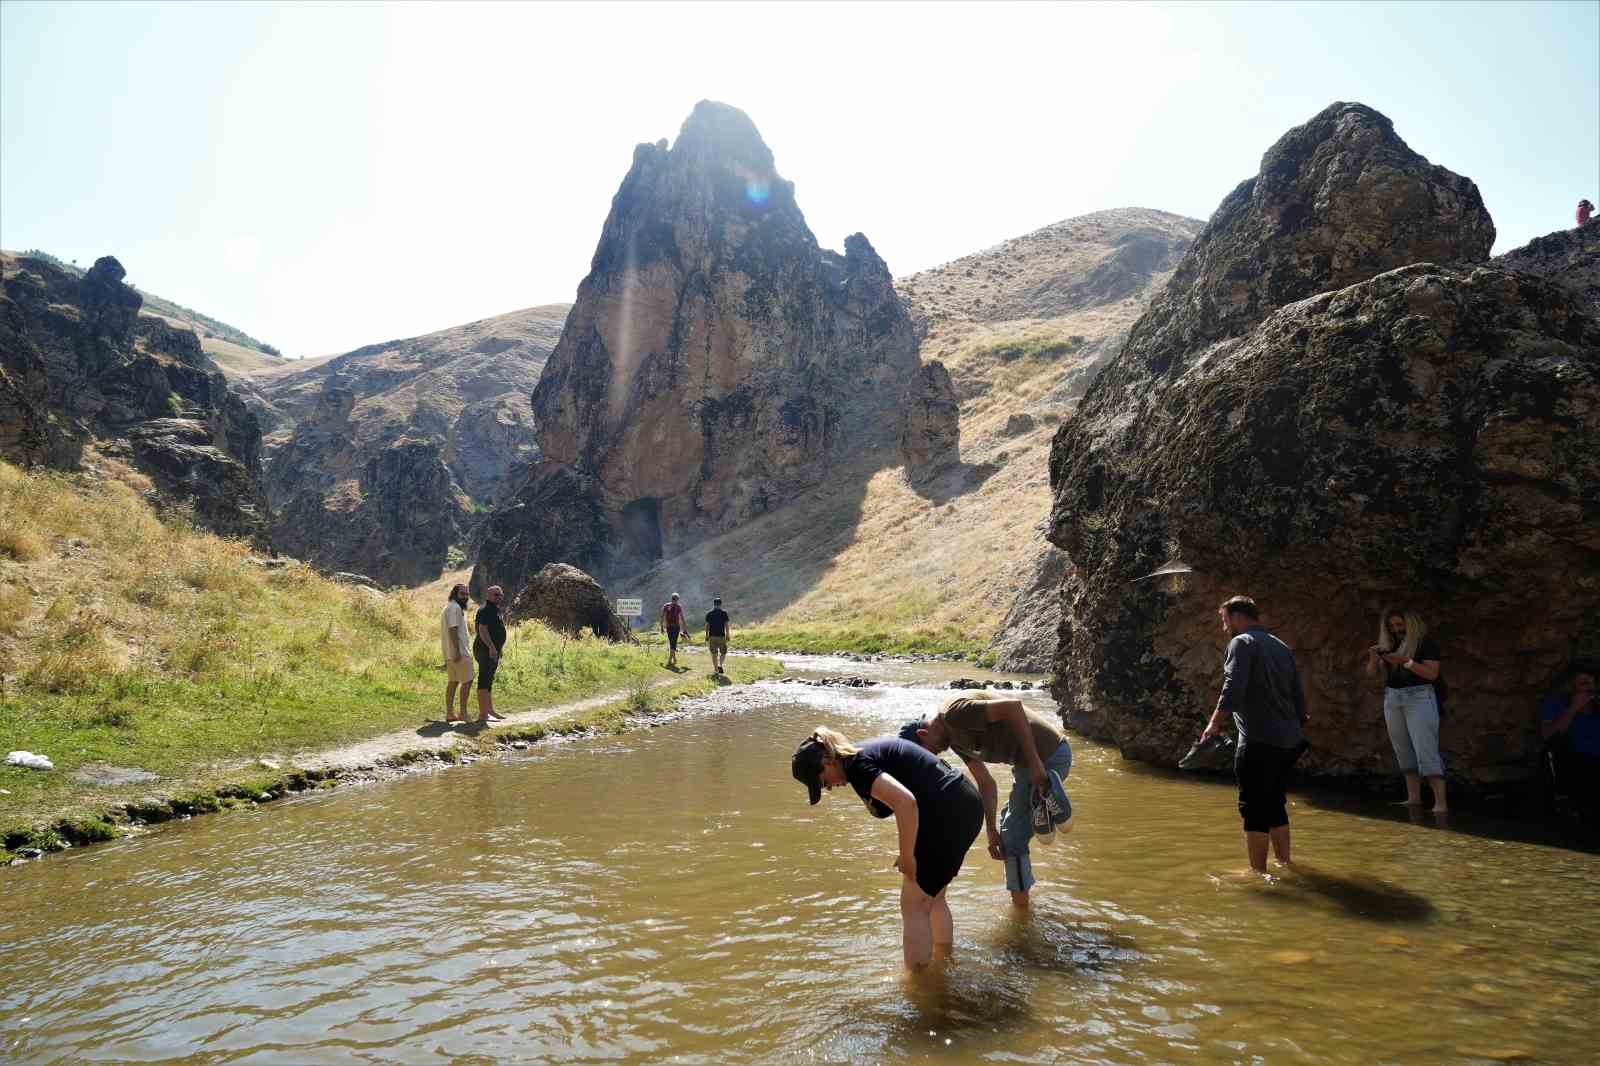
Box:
250;304;568;584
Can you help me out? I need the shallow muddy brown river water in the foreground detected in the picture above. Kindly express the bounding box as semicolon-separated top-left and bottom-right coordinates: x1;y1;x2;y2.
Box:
0;663;1600;1063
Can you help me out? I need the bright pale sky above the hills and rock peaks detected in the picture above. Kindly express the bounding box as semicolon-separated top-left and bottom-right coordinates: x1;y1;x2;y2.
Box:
0;0;1600;355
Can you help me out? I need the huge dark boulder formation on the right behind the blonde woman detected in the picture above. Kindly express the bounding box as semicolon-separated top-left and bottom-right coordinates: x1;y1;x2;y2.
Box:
1050;104;1600;779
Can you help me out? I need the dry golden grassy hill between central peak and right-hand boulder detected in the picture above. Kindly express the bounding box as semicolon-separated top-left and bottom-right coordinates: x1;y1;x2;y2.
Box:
585;208;1202;650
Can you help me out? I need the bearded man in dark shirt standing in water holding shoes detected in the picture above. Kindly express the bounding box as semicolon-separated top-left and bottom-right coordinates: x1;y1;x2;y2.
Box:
1200;595;1306;874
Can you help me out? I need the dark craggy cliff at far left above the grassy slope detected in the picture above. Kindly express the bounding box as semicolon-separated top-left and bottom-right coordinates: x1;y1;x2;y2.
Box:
0;256;267;543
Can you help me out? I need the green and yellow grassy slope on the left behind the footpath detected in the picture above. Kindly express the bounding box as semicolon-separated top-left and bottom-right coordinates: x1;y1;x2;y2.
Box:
0;463;774;836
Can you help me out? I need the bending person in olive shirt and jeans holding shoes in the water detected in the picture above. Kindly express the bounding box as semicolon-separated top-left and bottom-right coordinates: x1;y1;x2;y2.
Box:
899;691;1072;908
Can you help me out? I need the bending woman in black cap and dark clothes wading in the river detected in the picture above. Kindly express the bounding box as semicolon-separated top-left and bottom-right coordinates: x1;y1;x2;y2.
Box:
790;725;984;968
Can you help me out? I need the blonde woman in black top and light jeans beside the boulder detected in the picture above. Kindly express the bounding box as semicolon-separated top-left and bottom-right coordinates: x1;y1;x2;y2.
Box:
1366;608;1445;812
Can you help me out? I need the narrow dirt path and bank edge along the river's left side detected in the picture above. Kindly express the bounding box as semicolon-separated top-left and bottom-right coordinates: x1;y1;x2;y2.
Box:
0;646;782;866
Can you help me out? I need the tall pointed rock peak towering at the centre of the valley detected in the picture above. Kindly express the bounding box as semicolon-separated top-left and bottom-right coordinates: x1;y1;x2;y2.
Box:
477;101;917;584
